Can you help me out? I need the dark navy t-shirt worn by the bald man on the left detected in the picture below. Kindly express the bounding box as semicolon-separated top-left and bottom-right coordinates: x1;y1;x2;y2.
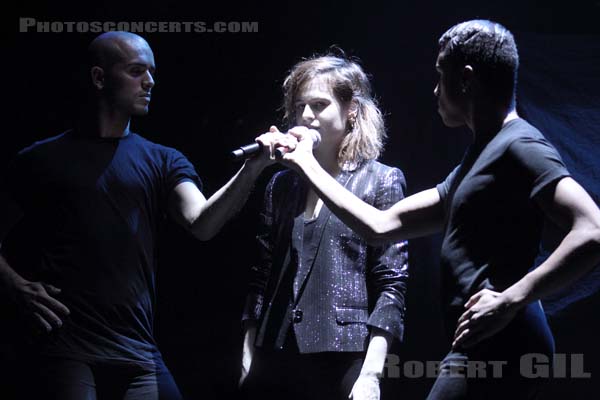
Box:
2;131;201;365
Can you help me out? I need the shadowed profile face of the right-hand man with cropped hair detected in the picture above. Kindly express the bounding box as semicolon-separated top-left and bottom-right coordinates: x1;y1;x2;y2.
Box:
433;52;465;127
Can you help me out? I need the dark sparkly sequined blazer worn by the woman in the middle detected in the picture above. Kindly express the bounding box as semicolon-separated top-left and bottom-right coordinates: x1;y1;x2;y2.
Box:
242;161;408;353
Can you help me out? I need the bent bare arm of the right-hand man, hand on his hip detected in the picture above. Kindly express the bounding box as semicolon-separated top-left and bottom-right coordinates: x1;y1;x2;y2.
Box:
454;178;600;347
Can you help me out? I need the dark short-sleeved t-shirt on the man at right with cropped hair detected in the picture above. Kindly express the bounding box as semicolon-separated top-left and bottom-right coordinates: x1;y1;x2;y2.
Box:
437;119;569;333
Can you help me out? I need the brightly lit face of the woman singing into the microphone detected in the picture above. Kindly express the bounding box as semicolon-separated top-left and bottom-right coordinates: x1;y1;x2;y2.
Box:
294;75;349;161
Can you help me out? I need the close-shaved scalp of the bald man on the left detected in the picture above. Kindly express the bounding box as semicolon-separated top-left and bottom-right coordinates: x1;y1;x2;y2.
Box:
88;31;150;70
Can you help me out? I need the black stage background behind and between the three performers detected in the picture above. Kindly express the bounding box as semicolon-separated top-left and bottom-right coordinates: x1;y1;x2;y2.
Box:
0;0;600;399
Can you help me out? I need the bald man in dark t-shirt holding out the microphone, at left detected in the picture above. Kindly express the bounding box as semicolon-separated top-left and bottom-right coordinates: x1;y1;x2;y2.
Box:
0;32;271;400
